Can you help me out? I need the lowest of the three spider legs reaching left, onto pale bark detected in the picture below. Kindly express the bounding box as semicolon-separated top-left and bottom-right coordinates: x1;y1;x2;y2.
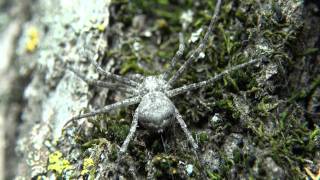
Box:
64;96;141;127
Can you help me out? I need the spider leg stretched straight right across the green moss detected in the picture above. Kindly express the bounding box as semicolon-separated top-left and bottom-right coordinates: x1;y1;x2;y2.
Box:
167;59;262;97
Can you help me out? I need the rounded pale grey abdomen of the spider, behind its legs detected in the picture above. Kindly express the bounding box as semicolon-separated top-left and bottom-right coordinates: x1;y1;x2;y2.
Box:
138;91;175;132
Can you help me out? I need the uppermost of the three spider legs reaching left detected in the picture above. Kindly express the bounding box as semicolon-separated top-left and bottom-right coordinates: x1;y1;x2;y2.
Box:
84;49;139;87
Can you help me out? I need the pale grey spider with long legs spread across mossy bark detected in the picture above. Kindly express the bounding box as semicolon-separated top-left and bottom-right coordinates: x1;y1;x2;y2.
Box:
65;0;261;176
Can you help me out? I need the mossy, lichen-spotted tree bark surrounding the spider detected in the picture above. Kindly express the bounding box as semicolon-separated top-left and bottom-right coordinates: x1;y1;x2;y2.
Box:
0;0;320;179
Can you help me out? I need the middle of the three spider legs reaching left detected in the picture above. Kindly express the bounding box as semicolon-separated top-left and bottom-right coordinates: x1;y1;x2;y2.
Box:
67;67;138;95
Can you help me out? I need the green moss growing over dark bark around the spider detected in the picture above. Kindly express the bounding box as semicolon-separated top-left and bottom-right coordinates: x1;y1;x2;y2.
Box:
54;0;312;179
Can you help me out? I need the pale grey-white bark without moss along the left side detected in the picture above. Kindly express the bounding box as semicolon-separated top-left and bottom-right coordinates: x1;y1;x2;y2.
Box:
0;0;110;179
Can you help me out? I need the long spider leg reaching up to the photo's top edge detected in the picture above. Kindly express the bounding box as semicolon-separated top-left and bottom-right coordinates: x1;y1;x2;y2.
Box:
168;0;221;86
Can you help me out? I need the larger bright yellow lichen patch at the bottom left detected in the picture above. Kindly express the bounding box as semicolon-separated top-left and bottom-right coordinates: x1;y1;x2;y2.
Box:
48;151;73;174
